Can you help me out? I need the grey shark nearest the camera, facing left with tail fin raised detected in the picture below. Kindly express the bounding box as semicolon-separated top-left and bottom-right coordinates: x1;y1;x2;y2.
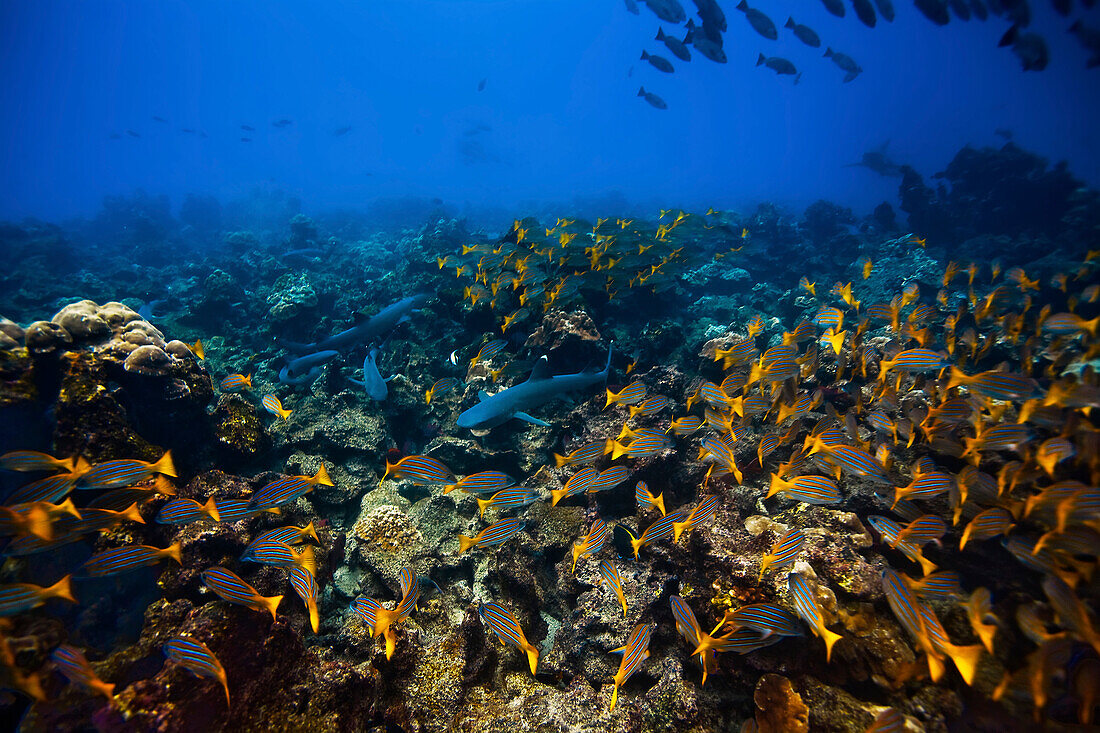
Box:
457;344;614;433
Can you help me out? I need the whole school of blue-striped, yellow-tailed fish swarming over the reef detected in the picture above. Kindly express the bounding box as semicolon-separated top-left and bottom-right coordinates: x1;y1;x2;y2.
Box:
0;206;1100;731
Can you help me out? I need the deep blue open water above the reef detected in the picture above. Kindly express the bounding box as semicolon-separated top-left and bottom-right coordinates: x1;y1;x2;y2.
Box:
0;0;1100;219
